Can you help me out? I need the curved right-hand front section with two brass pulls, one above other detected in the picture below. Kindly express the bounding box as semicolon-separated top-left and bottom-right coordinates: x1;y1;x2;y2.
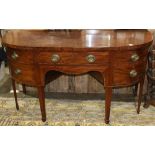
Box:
112;51;148;86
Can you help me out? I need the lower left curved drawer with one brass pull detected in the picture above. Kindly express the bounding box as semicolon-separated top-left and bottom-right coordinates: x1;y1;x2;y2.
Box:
9;63;36;85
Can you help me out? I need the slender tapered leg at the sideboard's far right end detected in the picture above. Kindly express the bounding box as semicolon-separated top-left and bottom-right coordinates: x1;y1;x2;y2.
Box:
137;78;144;114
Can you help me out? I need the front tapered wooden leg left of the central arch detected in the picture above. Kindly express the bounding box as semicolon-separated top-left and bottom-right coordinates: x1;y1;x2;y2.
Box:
38;86;46;122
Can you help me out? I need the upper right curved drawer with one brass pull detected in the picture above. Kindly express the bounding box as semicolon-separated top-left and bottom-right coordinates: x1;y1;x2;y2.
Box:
113;50;148;63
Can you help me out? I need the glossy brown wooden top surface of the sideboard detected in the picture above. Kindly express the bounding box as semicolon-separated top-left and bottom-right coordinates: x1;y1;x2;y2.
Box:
2;29;153;48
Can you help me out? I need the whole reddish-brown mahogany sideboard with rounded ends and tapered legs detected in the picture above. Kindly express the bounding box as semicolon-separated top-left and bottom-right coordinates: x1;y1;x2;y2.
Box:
2;29;153;124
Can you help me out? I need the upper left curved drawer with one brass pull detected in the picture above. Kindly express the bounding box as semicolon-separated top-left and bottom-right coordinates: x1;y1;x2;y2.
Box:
7;49;33;64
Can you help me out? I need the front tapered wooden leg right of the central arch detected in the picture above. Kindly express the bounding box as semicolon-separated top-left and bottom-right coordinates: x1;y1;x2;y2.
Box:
105;87;112;124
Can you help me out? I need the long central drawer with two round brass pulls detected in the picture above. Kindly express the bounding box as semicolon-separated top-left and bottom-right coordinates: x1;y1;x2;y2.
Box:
36;52;109;65
